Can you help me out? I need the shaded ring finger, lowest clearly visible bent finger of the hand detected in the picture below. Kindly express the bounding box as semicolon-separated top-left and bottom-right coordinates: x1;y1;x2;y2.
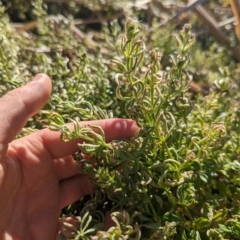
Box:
59;172;93;210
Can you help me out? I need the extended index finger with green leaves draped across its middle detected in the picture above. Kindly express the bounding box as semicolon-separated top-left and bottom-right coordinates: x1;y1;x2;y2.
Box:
39;119;139;158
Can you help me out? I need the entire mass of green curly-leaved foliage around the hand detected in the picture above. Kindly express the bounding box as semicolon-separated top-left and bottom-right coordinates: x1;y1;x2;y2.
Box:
0;1;240;240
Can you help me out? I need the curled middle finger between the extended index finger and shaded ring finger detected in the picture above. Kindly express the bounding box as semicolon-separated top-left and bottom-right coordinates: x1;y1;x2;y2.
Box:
54;155;81;180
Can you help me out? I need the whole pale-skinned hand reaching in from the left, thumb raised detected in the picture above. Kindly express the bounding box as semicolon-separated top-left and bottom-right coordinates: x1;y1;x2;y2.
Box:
0;74;139;240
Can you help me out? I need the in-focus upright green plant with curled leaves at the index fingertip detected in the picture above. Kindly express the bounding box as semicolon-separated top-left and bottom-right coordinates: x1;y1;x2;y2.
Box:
42;17;240;239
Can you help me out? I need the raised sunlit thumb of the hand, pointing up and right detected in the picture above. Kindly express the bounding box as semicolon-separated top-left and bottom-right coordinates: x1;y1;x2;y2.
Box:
0;74;52;159
